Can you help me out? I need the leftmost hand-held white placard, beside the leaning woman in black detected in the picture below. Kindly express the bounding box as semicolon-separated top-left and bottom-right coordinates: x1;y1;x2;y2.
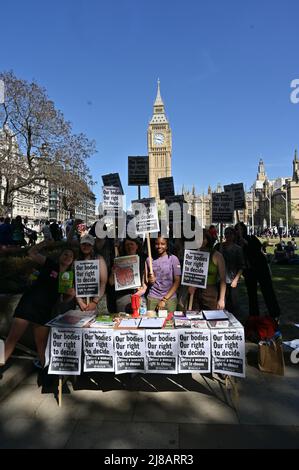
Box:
75;259;100;297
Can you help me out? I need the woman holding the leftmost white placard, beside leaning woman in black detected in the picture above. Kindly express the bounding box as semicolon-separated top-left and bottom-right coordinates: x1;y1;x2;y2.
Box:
76;234;108;313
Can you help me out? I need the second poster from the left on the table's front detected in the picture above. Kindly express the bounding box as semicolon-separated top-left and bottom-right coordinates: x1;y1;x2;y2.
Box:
83;328;114;372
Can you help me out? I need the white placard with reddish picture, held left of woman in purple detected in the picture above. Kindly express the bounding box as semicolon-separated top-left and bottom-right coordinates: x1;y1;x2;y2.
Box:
113;255;141;291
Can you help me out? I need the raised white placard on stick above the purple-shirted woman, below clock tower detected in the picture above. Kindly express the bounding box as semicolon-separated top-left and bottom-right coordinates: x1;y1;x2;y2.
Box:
132;197;159;235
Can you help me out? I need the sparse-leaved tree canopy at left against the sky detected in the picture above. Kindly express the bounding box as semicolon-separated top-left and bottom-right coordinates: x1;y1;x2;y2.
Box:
0;72;96;216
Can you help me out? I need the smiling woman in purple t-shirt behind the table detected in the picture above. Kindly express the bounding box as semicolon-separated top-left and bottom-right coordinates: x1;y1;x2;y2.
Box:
146;237;181;312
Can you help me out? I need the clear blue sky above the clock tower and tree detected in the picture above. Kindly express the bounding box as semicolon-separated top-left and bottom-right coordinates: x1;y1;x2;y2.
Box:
0;0;299;206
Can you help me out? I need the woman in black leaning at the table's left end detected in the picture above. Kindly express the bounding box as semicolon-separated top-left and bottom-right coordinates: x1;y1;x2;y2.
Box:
5;242;74;364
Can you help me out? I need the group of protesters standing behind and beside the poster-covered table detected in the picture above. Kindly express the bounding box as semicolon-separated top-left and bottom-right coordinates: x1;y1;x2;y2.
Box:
1;216;288;364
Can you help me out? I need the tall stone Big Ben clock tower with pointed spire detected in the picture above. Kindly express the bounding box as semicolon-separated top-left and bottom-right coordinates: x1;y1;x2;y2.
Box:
147;80;172;199
